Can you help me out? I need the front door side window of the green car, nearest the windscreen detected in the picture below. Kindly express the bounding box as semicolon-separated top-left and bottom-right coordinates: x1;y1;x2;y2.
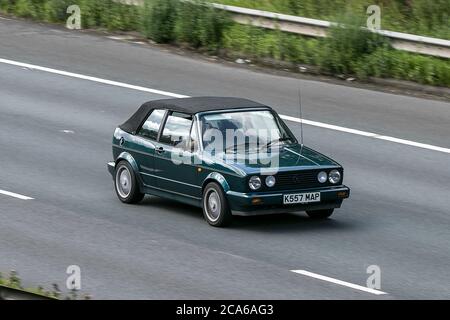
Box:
159;112;192;149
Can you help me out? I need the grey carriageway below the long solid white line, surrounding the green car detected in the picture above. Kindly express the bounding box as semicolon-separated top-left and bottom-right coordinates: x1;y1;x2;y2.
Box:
0;18;450;299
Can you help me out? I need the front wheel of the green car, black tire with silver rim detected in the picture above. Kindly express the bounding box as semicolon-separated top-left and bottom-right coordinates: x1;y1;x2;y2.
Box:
202;182;233;227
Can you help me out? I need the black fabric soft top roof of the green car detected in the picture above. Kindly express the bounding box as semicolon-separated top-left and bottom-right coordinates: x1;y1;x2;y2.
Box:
119;97;269;133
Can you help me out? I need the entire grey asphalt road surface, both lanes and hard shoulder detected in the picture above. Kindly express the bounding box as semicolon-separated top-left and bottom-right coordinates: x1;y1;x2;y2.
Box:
0;19;450;299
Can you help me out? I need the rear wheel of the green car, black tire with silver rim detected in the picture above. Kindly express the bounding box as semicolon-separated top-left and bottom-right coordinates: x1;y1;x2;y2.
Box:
114;161;145;203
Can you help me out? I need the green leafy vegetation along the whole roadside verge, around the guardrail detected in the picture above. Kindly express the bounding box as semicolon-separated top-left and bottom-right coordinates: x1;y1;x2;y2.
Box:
0;0;450;87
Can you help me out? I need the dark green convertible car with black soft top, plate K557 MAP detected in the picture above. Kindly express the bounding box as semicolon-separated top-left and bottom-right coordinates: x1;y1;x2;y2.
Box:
108;97;350;226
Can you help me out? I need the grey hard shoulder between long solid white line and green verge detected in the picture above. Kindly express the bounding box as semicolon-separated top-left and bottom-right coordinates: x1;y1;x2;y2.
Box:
0;16;450;147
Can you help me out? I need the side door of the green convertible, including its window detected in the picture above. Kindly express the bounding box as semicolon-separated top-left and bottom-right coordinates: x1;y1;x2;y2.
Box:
155;112;201;198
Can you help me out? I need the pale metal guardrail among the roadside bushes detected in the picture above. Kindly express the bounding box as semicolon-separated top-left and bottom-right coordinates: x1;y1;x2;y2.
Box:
212;3;450;58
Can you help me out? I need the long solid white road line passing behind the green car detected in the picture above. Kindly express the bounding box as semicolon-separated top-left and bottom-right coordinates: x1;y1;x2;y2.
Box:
0;58;450;154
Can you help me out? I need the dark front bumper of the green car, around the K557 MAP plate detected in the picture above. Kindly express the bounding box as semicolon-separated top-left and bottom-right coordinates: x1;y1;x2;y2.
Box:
226;185;350;216
